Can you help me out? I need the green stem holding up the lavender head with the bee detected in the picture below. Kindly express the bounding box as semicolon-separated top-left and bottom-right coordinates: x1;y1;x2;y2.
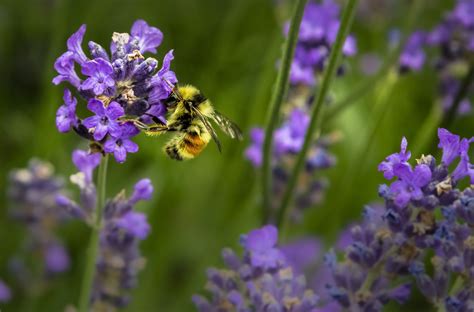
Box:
79;154;109;312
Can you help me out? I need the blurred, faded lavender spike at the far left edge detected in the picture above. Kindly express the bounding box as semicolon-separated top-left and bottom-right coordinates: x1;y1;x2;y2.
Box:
8;159;70;289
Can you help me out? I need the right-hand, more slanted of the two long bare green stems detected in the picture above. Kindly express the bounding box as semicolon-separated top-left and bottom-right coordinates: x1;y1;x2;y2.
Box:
276;0;358;233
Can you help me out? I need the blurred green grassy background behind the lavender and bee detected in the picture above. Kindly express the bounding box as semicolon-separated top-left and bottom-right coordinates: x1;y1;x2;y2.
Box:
0;0;473;311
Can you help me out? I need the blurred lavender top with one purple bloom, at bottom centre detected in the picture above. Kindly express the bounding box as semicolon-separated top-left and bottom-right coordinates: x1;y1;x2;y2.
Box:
193;225;318;312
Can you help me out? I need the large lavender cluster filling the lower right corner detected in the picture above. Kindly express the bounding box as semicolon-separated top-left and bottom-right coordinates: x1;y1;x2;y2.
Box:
326;129;474;312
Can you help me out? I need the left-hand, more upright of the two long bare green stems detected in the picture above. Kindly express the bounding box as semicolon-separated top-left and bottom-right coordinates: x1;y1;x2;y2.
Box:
262;0;308;223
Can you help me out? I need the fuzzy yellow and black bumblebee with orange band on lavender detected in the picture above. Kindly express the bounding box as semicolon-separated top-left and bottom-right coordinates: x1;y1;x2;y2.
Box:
132;85;242;160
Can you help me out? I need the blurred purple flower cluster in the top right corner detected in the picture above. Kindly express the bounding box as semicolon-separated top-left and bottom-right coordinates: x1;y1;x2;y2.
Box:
400;0;474;114
